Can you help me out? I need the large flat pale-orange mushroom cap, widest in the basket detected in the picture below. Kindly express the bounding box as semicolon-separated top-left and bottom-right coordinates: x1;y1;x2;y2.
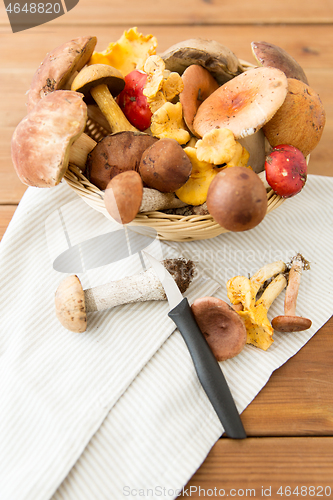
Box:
193;67;288;139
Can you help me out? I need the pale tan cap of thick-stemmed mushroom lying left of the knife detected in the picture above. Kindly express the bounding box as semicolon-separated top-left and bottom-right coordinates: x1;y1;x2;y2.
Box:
55;275;87;333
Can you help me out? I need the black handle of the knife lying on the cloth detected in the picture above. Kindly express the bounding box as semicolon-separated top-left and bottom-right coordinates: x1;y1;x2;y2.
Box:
168;298;246;439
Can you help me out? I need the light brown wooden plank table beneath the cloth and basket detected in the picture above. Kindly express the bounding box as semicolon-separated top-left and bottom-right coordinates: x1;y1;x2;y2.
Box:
0;0;333;499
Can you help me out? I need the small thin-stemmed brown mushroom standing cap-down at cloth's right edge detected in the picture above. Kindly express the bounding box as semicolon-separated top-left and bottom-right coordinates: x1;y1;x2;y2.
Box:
272;254;312;332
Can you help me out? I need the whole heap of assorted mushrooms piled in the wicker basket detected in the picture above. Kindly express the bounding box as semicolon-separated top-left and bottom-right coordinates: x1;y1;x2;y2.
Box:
12;28;325;231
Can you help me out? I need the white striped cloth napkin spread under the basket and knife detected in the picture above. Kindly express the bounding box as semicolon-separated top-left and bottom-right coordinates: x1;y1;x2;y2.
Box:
0;176;333;500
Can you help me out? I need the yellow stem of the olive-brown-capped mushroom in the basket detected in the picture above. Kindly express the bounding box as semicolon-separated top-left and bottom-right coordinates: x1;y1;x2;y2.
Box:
90;83;138;133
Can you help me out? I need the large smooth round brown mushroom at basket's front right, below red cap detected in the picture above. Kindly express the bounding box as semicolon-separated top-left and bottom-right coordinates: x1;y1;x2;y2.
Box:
207;167;267;231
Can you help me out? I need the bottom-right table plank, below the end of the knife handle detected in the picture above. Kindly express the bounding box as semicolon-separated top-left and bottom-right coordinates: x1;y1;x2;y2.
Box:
182;437;333;500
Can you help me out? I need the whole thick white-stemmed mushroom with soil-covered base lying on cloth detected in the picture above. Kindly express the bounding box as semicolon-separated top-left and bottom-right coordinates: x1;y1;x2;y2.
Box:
55;259;194;333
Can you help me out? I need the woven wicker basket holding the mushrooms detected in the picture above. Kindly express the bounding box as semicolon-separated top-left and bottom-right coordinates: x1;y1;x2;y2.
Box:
65;60;284;241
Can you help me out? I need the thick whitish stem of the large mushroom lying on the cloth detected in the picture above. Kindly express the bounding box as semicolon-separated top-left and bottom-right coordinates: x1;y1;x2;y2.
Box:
84;269;166;313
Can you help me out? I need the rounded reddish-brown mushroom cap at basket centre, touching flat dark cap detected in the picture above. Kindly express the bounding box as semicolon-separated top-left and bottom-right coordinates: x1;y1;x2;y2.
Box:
139;139;192;193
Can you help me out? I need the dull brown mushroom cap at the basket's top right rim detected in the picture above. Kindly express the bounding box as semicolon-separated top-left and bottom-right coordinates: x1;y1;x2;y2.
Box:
251;42;308;84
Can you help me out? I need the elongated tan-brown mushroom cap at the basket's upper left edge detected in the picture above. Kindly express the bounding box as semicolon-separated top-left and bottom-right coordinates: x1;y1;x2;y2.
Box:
27;36;97;113
